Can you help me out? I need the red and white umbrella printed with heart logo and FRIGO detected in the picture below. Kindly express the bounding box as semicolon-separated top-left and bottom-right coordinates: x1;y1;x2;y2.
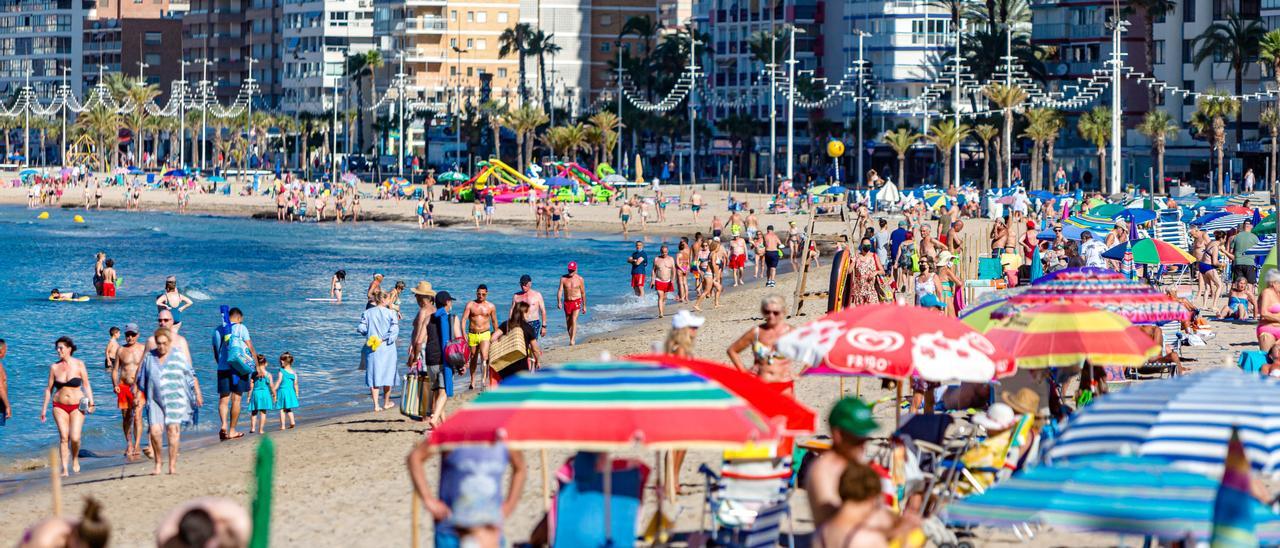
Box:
777;303;1014;383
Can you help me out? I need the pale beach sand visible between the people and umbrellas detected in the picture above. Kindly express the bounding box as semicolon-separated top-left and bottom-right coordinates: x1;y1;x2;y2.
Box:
0;179;1253;547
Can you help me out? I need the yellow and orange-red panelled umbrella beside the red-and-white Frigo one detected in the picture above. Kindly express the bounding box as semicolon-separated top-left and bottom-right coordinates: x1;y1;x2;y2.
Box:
983;303;1160;369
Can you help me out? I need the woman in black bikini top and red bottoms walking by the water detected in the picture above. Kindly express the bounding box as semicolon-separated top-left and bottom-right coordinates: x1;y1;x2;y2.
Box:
40;337;93;476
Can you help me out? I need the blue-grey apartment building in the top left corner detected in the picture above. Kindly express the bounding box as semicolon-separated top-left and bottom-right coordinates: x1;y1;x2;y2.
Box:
0;0;93;97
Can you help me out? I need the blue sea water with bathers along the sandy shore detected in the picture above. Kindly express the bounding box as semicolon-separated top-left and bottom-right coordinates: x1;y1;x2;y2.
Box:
0;207;657;466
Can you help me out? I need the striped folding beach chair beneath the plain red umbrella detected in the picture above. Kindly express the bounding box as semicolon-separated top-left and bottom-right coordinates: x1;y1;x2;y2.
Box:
699;457;795;548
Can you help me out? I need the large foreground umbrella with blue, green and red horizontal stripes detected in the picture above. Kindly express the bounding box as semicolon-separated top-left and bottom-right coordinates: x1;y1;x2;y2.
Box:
430;361;777;451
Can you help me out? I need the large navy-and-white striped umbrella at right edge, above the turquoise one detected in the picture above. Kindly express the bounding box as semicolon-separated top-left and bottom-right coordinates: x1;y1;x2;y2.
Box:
1048;367;1280;474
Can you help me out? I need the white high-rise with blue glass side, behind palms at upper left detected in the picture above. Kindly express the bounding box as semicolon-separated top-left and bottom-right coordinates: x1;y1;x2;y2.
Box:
282;0;374;113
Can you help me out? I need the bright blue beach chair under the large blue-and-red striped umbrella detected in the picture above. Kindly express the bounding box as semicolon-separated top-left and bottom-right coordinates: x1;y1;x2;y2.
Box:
552;452;649;548
